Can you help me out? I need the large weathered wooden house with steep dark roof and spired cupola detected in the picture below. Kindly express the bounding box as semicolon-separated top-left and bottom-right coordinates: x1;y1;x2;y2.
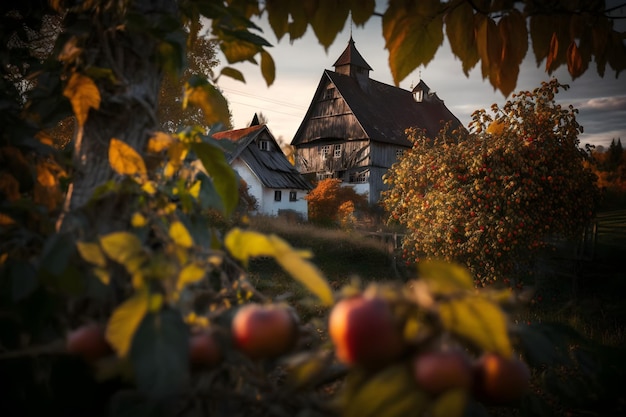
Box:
291;37;462;204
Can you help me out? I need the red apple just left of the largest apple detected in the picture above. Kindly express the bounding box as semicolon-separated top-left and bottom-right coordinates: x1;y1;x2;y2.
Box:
231;304;298;359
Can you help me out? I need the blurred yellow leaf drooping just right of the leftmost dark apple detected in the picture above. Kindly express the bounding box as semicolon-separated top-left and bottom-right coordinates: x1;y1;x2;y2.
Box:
106;290;150;357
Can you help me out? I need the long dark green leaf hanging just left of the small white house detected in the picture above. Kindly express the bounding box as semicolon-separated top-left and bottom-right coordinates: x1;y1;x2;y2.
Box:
191;142;239;215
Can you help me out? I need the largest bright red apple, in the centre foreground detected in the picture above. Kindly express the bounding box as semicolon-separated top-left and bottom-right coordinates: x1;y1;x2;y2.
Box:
328;295;404;369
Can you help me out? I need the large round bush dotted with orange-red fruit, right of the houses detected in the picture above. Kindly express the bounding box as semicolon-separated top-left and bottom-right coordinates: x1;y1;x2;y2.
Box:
383;80;598;284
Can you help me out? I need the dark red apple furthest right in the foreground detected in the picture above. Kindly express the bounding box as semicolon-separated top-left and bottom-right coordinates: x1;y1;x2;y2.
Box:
473;353;530;404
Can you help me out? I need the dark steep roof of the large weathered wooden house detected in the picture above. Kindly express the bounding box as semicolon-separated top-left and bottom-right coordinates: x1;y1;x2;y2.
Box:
291;70;461;146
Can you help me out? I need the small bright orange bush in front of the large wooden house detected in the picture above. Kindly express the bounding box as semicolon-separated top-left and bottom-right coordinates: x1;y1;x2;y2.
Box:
305;178;367;225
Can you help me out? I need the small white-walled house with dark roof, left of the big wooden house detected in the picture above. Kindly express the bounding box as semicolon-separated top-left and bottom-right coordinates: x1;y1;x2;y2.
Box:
213;115;313;220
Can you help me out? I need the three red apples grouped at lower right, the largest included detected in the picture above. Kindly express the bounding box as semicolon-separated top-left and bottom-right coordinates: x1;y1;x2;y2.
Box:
329;294;530;404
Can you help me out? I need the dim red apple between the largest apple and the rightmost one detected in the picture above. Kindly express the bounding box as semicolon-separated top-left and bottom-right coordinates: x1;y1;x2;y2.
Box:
413;351;473;395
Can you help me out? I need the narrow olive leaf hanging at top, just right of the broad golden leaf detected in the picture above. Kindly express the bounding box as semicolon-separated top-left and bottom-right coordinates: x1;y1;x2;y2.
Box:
445;2;479;76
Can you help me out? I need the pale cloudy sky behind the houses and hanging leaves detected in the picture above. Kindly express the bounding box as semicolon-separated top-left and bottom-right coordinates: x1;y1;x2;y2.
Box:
218;6;626;147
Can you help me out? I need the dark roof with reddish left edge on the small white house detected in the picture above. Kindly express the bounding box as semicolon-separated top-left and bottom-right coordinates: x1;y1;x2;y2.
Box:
213;125;313;190
